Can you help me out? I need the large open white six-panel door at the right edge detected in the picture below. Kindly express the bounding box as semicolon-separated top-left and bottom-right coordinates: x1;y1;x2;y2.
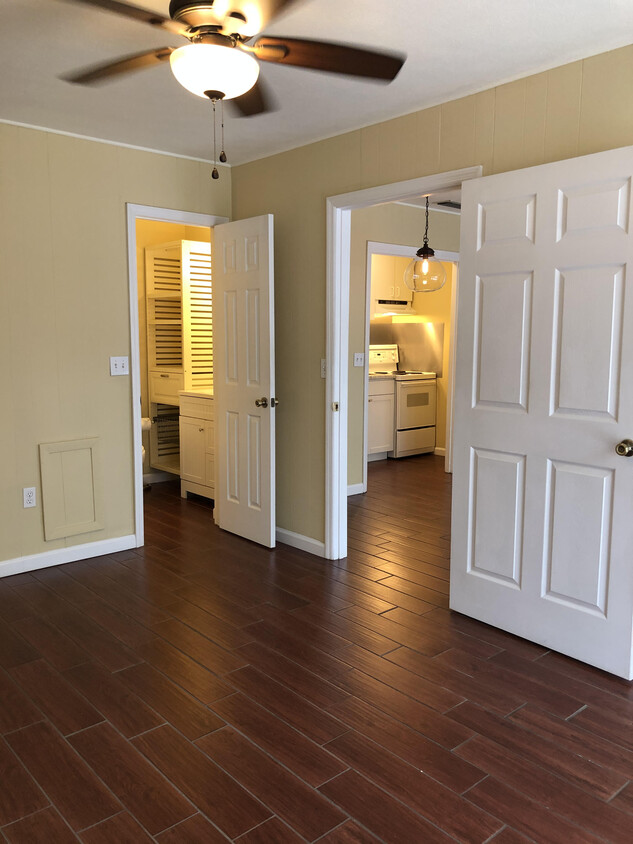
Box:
451;148;633;679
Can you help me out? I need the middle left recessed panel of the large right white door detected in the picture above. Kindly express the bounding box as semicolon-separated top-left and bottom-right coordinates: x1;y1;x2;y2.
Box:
473;273;532;412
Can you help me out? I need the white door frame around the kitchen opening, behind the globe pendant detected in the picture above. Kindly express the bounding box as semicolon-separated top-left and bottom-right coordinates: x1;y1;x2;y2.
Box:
356;240;459;495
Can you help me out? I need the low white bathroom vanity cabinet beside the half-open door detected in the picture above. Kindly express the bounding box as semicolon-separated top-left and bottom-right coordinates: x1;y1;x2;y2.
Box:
179;390;215;498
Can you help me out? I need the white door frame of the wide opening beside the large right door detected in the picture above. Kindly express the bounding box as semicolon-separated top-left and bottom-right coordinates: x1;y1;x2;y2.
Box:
325;165;482;560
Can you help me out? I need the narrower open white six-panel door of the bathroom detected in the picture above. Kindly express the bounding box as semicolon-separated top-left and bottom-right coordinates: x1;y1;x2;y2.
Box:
213;215;275;548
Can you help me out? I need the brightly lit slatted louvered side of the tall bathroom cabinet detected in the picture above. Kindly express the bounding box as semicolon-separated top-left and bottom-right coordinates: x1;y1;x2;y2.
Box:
182;240;213;390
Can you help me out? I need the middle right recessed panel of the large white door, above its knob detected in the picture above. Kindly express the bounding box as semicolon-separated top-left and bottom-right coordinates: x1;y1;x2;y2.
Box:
551;266;624;419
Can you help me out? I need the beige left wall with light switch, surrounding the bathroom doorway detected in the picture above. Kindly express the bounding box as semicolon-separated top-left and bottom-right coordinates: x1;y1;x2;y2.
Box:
0;124;231;560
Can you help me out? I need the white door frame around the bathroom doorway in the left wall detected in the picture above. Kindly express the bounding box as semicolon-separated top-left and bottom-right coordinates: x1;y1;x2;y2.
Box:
126;202;229;548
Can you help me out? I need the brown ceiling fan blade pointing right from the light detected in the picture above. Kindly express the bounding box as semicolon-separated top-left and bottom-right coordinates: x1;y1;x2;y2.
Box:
252;35;404;82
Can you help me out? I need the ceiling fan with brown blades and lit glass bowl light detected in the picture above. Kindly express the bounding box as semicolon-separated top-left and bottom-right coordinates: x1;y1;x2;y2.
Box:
64;0;404;117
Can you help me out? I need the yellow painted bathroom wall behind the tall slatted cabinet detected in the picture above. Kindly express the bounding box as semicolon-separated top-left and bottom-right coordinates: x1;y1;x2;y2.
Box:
136;220;211;474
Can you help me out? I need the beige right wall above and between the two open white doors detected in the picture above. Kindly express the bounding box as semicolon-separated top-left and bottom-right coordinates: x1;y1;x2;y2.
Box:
232;47;633;540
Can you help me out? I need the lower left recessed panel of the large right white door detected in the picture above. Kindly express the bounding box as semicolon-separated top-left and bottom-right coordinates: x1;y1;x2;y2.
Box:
468;449;525;589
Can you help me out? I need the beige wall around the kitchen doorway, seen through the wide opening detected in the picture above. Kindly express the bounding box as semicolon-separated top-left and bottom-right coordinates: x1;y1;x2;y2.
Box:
347;204;459;485
